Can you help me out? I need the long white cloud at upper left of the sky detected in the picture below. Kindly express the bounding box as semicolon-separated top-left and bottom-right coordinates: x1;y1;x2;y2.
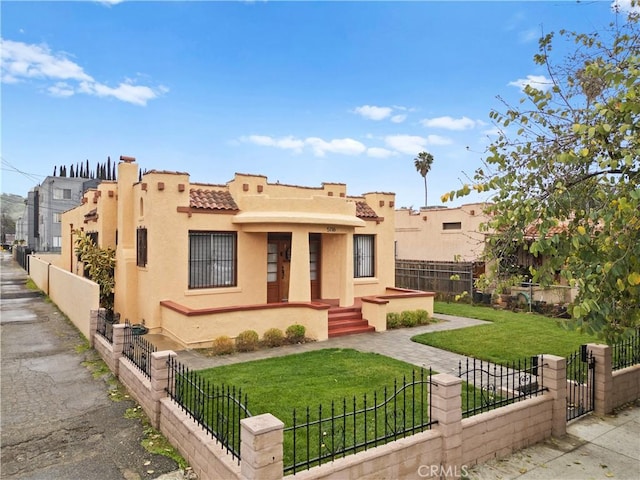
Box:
0;39;168;105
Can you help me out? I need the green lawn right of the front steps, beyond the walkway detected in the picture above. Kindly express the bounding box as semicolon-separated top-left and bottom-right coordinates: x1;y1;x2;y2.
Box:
412;302;598;363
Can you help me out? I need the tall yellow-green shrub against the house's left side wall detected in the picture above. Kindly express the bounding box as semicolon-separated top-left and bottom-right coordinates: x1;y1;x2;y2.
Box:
73;230;119;323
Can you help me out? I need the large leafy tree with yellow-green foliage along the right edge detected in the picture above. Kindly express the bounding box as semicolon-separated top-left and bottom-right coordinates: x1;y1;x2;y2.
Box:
442;14;640;342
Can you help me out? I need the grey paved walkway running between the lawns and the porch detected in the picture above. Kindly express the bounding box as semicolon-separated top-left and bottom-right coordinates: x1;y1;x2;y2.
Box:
176;314;489;375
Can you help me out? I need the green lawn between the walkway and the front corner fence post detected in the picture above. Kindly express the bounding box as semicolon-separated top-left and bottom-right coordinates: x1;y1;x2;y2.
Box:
198;349;436;466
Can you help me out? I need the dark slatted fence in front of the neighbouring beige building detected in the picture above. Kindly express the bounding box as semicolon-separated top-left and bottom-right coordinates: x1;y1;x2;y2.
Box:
396;260;474;296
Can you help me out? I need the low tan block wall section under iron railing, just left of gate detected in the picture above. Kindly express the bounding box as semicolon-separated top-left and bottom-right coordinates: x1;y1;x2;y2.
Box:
462;395;553;465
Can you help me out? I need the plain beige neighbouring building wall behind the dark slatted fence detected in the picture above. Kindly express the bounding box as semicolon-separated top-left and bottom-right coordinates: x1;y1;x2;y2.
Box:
395;203;488;262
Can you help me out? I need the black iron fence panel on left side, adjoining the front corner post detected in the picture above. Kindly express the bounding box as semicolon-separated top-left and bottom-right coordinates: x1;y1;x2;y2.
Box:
167;357;252;464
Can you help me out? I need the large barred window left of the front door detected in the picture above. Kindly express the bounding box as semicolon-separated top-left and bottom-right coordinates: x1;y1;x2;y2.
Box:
189;232;237;288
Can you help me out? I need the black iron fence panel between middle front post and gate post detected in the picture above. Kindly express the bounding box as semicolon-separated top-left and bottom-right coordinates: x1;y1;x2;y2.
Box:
458;356;547;418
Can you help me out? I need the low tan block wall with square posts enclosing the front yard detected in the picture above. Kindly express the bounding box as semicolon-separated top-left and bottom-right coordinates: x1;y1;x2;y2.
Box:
90;312;640;480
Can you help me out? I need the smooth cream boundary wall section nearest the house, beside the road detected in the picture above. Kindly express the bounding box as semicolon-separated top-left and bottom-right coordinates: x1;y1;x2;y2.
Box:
49;266;100;339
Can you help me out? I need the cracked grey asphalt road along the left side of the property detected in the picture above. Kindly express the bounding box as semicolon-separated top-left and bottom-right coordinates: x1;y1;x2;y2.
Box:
0;252;178;480
